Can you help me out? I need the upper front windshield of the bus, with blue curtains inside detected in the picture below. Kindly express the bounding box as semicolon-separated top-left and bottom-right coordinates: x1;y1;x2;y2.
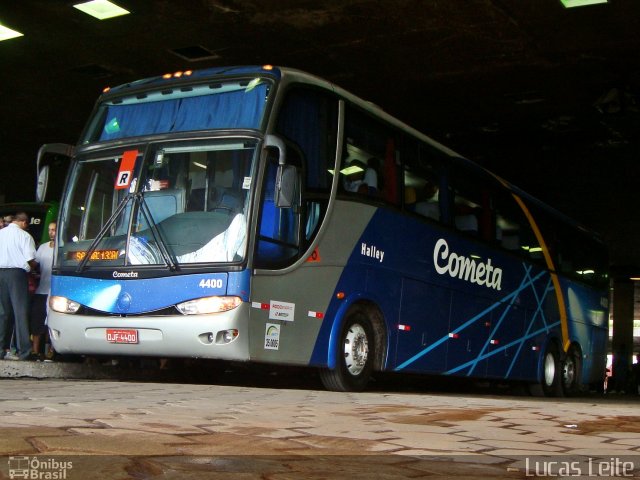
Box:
81;77;271;144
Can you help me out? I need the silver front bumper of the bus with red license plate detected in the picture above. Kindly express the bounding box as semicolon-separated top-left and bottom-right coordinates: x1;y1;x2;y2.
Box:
48;303;250;361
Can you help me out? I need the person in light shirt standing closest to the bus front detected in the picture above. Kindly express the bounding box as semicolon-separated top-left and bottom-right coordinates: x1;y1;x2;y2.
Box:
30;222;56;360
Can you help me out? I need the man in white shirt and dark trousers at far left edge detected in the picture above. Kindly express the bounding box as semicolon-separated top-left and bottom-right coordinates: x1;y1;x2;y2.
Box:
0;212;36;360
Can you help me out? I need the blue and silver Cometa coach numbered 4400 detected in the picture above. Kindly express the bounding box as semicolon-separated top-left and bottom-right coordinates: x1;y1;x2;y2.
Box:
43;66;608;395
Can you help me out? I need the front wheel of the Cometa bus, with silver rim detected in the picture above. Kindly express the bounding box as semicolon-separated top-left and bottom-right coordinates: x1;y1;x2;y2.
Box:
320;307;376;392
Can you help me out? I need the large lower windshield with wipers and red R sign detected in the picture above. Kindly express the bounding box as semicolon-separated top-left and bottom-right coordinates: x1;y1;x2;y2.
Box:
58;139;258;269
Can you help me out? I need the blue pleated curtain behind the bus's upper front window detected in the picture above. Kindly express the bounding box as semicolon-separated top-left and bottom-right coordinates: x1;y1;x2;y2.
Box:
99;84;267;141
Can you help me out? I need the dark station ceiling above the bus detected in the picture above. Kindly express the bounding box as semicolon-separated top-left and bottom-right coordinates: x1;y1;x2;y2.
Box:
0;0;640;267
